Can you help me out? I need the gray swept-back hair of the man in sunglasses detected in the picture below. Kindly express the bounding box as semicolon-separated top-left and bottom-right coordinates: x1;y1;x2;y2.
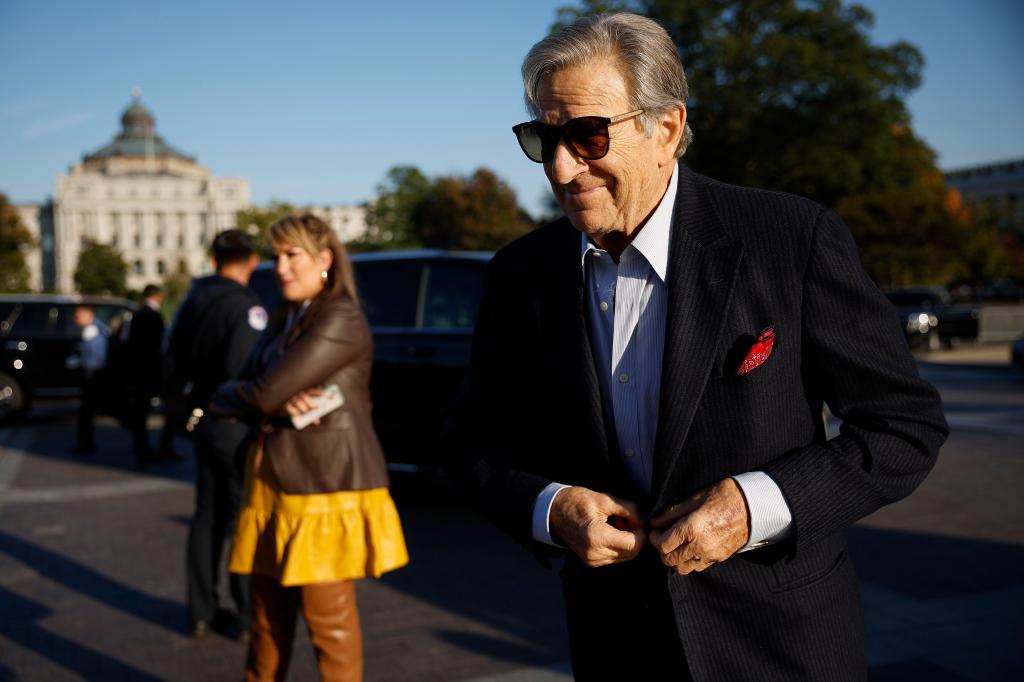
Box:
522;13;693;159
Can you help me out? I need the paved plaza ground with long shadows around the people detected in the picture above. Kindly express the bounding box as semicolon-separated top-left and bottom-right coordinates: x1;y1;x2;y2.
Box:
0;363;1024;682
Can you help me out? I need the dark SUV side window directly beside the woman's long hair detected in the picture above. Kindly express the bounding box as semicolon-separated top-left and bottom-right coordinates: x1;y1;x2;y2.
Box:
354;260;423;327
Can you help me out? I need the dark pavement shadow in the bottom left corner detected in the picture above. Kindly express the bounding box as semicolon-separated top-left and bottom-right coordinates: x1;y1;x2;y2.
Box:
0;586;161;682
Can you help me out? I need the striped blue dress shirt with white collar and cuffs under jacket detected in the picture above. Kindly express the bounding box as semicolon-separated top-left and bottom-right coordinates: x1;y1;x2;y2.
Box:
532;168;793;551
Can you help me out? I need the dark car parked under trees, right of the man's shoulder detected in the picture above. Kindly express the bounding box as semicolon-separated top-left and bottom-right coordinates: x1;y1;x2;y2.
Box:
886;287;981;350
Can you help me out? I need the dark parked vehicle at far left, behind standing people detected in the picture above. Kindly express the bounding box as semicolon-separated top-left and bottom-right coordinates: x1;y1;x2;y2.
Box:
0;294;135;418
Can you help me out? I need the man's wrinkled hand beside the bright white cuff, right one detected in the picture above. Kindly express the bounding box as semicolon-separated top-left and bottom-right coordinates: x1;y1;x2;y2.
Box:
650;478;750;576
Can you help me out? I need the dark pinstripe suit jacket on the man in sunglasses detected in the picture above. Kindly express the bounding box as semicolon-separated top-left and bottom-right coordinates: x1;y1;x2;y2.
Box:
447;164;947;680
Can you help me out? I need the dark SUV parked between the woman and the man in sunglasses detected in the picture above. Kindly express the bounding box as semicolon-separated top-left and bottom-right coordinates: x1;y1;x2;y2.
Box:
250;250;492;471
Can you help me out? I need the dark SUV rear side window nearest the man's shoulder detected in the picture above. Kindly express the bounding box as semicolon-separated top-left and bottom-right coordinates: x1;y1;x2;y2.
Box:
423;261;485;329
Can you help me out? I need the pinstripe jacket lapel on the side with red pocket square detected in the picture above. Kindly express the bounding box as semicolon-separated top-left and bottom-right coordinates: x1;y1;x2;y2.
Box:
651;164;743;503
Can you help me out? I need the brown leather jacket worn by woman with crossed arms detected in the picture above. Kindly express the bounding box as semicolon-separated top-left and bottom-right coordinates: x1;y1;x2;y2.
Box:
210;295;388;495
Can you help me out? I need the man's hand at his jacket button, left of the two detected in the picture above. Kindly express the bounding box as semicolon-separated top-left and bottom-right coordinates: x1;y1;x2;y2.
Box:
549;485;647;568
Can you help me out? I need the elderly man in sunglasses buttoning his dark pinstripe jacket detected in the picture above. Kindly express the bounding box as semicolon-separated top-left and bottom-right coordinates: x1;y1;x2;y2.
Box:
446;14;947;680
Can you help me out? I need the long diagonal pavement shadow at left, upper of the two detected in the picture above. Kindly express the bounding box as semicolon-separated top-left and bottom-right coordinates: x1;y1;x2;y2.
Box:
0;530;186;630
